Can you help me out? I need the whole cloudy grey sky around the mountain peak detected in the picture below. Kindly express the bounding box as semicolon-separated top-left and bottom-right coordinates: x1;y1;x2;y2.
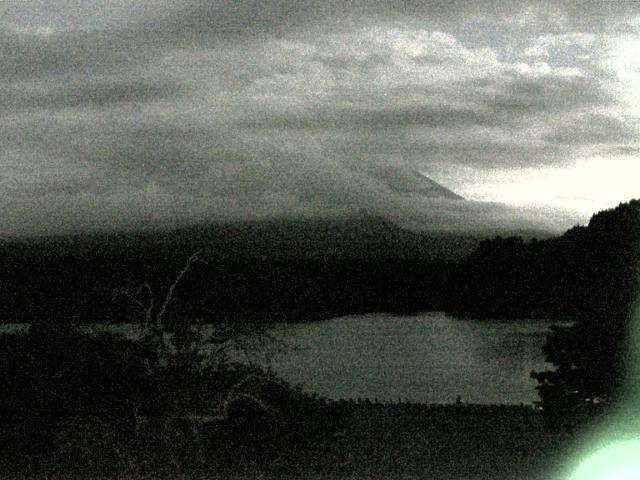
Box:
0;0;640;235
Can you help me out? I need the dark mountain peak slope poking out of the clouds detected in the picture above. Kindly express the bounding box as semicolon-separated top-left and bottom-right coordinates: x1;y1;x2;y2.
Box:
373;165;464;200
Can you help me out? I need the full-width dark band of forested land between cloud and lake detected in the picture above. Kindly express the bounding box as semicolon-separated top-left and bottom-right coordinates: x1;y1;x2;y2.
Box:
0;202;638;323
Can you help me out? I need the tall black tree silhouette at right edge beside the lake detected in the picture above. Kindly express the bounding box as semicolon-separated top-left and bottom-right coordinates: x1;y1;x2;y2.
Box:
532;200;640;429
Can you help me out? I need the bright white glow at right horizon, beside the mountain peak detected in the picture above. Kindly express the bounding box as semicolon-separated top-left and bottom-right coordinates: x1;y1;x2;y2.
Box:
458;157;640;215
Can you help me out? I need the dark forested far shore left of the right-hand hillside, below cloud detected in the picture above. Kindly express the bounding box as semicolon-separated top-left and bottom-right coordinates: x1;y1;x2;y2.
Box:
0;217;476;323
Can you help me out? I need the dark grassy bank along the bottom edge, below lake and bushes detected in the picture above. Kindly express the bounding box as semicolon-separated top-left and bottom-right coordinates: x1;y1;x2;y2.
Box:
0;400;571;480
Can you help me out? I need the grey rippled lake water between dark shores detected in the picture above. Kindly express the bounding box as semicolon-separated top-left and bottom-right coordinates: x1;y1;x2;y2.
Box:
0;312;552;404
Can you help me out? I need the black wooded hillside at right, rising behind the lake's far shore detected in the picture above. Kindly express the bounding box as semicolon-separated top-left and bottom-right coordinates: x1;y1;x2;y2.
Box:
447;200;640;320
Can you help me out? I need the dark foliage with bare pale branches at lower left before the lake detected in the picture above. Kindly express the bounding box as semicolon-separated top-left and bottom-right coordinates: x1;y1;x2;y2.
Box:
0;254;344;474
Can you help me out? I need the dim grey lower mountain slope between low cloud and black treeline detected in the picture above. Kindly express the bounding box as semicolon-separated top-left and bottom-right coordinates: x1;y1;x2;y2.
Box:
0;216;478;265
